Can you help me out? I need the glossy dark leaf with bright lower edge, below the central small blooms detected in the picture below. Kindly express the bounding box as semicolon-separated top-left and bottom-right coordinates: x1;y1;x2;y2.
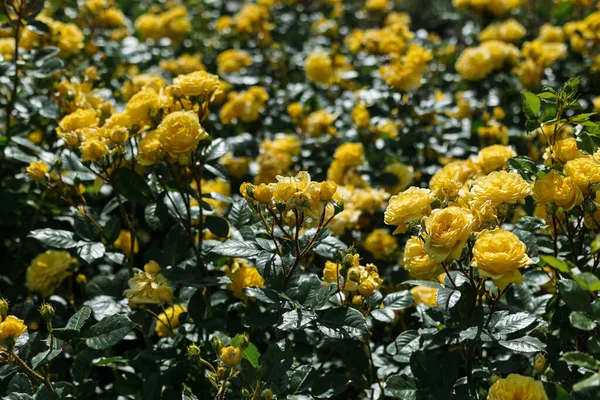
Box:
317;308;368;340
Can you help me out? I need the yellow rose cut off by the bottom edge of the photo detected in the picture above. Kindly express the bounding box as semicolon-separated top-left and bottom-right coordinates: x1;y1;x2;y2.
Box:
487;374;548;400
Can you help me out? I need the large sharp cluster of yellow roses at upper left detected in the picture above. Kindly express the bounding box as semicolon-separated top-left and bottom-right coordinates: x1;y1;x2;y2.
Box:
47;70;219;167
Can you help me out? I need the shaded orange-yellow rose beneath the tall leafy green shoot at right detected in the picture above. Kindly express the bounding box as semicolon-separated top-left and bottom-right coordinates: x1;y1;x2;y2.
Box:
533;170;583;211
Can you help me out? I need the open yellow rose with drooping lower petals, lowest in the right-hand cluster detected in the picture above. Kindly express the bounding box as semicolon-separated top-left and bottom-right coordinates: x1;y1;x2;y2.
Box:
471;229;533;290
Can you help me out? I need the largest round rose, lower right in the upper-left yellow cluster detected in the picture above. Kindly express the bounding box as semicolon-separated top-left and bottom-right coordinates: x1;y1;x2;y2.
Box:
156;111;209;158
